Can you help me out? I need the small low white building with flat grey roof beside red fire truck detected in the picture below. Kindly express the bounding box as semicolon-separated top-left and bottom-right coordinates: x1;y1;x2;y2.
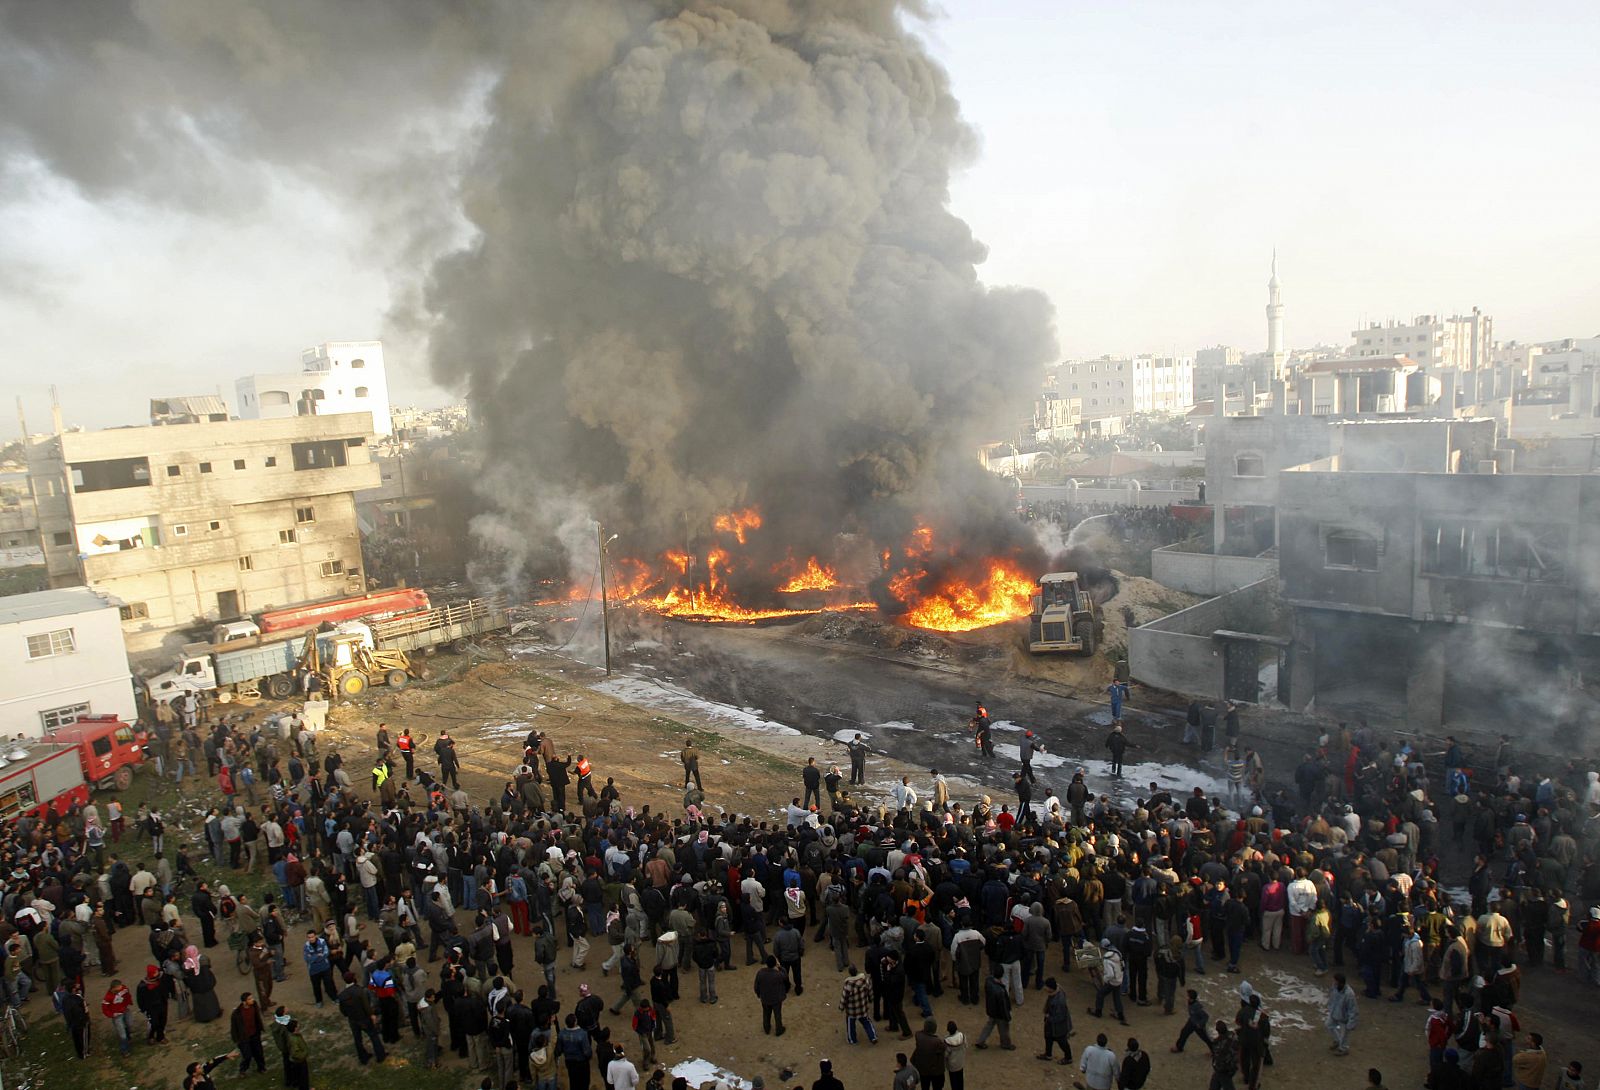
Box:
0;587;138;738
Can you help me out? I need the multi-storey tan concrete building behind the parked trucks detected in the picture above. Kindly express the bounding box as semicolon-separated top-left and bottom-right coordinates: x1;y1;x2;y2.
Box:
29;413;379;653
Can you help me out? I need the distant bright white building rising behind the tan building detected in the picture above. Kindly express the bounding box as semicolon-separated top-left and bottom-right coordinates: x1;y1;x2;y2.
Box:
234;341;394;435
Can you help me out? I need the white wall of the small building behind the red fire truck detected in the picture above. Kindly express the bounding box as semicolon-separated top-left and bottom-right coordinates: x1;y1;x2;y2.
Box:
0;603;139;738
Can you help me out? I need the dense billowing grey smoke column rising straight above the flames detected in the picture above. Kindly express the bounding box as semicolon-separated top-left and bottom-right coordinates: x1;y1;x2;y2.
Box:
429;0;1053;592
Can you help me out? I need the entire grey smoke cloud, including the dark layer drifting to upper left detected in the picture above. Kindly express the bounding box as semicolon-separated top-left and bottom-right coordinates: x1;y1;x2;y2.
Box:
0;0;1054;595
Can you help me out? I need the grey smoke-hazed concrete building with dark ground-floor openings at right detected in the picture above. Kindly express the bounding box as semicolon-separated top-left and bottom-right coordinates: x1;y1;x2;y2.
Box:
1278;421;1600;733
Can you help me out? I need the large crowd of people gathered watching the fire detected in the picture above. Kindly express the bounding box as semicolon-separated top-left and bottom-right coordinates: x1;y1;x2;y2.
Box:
0;697;1600;1090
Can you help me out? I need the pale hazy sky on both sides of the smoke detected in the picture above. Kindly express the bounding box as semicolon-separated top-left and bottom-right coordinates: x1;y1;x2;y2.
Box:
0;0;1600;435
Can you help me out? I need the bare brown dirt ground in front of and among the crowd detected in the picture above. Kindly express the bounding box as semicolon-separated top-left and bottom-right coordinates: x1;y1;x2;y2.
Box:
30;646;1600;1090
